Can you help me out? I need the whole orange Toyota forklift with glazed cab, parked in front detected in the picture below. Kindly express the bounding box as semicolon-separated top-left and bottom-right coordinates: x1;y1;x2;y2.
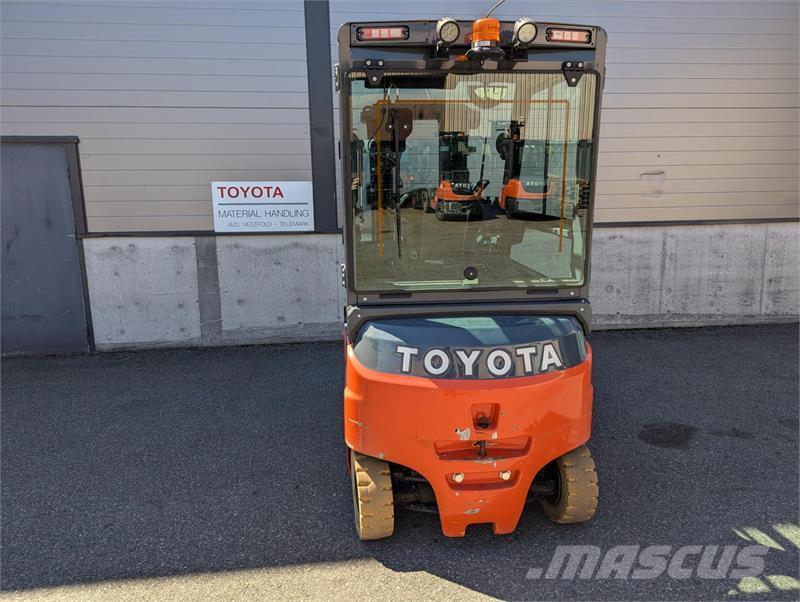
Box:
334;11;606;540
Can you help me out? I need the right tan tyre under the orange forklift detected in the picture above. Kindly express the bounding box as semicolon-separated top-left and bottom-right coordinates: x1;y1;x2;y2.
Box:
539;445;599;523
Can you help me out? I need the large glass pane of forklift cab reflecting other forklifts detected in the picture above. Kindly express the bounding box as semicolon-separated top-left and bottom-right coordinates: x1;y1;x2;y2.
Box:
348;73;596;291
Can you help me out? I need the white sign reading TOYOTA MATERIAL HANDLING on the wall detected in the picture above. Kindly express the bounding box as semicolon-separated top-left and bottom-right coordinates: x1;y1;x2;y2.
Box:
211;182;314;232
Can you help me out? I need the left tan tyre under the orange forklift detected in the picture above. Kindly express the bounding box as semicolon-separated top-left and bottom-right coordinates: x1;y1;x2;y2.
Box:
350;452;394;540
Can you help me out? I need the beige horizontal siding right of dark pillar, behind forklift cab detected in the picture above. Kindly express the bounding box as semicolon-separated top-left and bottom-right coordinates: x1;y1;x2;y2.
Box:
331;0;800;222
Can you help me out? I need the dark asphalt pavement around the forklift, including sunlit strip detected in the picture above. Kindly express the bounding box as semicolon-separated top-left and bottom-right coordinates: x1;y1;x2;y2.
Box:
0;326;800;600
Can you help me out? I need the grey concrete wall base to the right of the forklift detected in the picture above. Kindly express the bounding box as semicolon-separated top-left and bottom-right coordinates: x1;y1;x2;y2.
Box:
590;223;800;328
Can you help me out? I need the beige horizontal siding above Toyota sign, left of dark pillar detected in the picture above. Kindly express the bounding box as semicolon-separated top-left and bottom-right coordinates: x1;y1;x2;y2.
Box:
0;0;311;231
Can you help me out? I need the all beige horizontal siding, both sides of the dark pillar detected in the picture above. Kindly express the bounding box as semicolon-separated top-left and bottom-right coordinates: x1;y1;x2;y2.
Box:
0;0;798;231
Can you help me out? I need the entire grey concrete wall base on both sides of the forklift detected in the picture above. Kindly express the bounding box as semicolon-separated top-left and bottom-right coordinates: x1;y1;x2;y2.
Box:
84;223;800;350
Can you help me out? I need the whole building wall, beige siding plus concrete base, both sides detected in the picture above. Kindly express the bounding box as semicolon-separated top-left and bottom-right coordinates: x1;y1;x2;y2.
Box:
0;0;800;349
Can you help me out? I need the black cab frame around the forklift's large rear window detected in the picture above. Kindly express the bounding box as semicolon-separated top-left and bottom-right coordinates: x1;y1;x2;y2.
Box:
334;20;607;335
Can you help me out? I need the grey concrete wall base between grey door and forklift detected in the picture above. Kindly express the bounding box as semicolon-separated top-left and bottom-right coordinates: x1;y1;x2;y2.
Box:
84;235;344;350
